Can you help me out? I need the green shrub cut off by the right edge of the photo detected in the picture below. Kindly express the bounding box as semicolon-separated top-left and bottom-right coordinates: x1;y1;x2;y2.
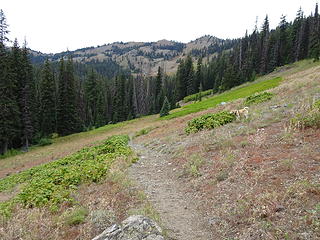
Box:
289;100;320;129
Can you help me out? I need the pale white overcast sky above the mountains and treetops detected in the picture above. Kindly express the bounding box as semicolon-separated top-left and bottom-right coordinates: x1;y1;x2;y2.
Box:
0;0;317;53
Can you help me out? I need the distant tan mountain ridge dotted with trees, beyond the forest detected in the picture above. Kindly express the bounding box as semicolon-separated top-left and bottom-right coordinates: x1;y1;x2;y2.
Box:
31;35;236;75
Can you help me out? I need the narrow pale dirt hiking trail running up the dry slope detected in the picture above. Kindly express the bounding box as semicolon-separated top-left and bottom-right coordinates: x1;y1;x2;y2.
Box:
129;142;212;240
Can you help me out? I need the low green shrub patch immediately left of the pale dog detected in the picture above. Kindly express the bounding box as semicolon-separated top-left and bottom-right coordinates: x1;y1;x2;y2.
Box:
185;111;236;134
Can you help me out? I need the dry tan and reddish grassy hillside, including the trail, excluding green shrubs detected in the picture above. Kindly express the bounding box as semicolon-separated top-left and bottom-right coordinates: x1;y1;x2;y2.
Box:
0;61;320;240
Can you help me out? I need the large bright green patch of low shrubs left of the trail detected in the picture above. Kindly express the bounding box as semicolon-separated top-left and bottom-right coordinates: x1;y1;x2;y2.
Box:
0;136;131;216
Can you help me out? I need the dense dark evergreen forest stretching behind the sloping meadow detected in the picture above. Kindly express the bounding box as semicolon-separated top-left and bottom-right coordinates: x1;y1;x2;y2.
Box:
0;5;320;154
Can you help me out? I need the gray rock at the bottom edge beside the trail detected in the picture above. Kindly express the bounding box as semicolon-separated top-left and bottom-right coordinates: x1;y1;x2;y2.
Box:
92;215;164;240
